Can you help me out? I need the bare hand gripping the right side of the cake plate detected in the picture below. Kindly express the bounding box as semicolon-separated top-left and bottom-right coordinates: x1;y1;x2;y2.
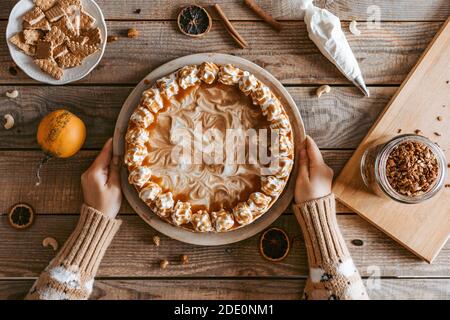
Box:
295;136;333;204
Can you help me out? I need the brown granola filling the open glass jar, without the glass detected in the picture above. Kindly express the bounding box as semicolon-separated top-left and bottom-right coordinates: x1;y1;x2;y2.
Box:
386;141;439;197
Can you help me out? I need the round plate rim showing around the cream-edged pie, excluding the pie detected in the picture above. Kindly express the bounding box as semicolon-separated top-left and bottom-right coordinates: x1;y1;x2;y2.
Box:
113;53;306;246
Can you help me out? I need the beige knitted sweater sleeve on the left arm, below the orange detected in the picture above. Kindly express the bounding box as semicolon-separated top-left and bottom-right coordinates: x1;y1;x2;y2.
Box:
26;205;122;300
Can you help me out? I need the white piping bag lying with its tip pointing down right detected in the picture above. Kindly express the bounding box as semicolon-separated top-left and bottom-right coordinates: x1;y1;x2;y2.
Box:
299;0;369;97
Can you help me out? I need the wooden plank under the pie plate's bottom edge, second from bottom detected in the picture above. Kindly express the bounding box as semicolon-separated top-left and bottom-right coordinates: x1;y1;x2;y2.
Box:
0;213;450;277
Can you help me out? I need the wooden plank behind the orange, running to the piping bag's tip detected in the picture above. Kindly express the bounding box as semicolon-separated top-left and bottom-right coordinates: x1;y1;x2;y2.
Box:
0;86;397;149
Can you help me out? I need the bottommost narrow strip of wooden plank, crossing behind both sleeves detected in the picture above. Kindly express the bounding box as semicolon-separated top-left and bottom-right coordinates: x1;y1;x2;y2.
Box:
0;278;450;300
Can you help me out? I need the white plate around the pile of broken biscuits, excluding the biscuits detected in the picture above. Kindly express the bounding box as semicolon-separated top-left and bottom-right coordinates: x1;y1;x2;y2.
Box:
6;0;107;85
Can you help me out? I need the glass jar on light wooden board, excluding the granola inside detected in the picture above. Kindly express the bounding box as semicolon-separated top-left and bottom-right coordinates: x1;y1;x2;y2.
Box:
360;134;447;204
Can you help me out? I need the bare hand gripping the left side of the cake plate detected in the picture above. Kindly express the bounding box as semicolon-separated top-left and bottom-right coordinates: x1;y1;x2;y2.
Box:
81;138;122;218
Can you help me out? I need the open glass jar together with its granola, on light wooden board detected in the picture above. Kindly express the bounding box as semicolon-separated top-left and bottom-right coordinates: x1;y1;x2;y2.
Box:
361;134;446;204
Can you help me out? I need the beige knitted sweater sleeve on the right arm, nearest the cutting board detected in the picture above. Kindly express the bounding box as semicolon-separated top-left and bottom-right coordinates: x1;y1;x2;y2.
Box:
294;194;369;300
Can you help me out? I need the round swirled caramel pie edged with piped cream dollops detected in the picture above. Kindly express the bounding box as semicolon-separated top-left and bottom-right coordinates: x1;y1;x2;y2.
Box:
124;62;294;232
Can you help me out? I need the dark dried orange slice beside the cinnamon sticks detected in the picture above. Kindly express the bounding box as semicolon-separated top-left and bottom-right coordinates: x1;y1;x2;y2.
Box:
178;5;212;37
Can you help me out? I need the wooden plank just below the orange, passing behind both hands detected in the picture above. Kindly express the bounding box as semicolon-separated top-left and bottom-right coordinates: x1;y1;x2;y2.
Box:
0;150;352;215
